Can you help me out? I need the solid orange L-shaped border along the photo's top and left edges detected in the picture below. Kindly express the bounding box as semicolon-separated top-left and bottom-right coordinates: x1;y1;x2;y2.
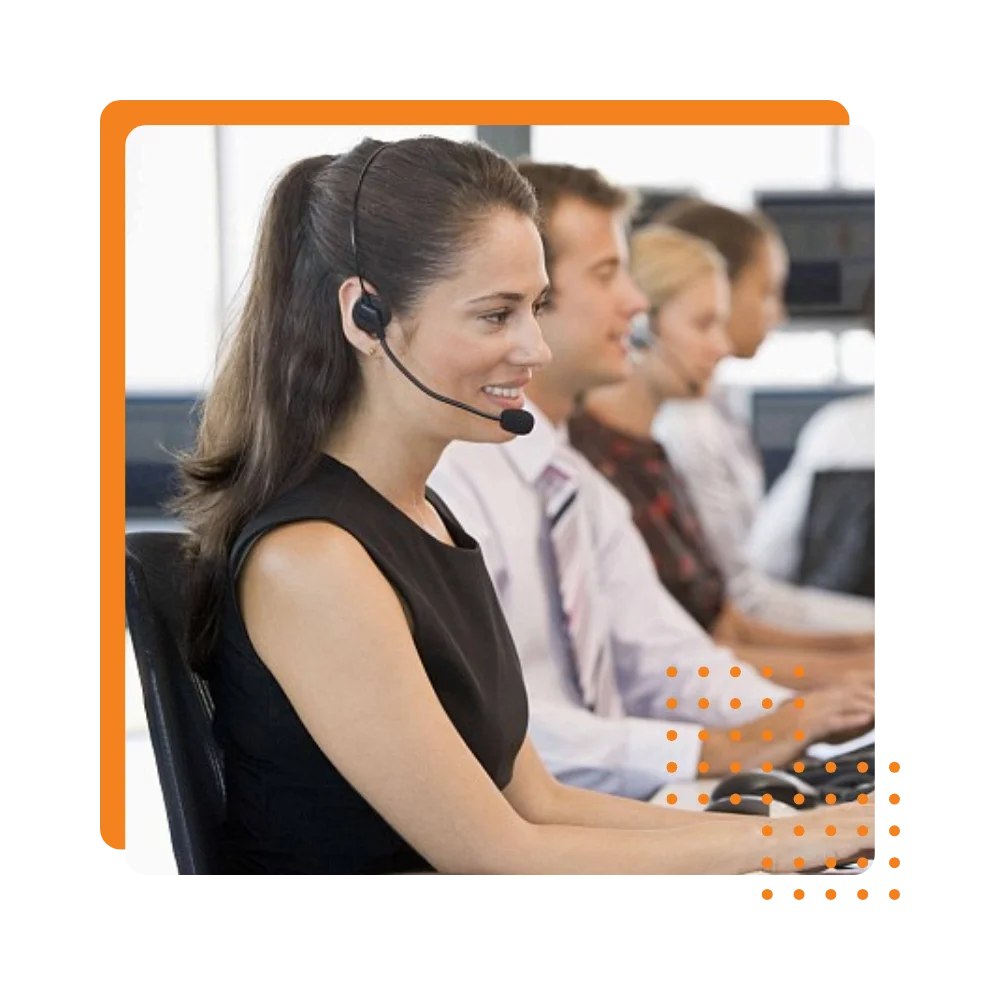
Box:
98;98;851;851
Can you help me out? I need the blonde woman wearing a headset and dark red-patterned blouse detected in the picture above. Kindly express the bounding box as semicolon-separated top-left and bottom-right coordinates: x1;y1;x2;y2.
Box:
569;224;875;686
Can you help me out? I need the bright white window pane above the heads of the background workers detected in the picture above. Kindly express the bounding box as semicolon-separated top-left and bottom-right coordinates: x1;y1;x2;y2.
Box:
531;125;833;209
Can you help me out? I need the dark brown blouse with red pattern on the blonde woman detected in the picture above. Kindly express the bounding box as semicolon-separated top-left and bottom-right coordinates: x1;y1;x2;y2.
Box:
569;412;726;631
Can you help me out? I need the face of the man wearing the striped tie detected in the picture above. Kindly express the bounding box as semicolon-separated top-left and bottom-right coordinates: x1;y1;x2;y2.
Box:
536;197;649;401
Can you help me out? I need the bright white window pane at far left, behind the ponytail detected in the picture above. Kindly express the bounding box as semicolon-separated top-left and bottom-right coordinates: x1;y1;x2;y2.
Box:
125;125;219;392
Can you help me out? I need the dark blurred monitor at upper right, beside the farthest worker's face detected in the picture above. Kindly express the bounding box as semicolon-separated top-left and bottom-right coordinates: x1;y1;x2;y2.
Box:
754;191;879;319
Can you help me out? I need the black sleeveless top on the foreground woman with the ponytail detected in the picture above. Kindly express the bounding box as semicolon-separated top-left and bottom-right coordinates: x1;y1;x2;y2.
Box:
207;455;528;879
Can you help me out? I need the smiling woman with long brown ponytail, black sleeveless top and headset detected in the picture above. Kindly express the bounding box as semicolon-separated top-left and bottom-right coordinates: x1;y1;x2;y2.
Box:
164;137;877;879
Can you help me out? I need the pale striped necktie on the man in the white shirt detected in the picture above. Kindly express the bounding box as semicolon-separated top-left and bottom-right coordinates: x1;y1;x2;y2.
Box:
538;458;621;716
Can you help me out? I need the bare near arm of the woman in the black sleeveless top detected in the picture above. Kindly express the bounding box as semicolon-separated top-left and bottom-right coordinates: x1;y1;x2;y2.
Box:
240;522;877;877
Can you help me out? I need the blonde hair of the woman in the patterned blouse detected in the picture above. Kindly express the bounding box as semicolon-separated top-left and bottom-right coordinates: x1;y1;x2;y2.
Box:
631;223;727;314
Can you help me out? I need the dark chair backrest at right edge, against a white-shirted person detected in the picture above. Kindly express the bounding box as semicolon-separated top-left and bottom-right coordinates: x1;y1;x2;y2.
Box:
798;468;880;599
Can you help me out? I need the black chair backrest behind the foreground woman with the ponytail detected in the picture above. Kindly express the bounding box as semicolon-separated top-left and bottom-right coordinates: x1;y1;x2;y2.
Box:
125;531;226;879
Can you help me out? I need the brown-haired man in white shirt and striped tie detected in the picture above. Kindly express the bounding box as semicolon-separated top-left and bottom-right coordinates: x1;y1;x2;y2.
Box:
429;163;875;799
